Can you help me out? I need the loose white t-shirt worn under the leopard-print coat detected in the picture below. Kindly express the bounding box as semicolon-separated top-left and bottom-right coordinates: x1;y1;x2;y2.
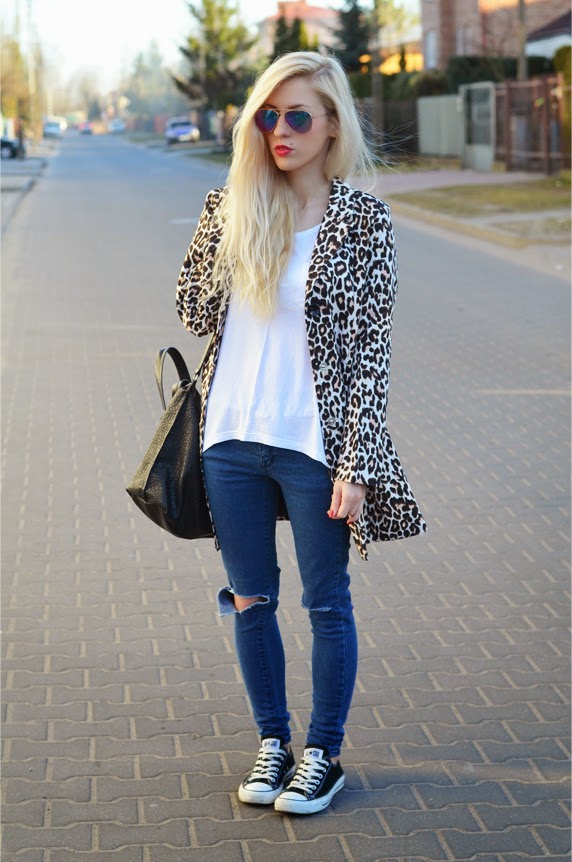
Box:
203;225;327;466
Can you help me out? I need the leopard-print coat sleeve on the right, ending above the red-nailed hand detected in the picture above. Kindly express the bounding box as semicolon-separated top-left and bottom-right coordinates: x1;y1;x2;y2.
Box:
335;200;397;487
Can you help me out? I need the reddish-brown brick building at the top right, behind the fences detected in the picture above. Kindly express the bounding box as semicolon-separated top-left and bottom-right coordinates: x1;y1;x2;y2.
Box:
421;0;570;69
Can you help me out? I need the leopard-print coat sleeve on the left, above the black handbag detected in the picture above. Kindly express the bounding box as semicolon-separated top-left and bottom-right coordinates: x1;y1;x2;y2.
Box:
176;189;223;336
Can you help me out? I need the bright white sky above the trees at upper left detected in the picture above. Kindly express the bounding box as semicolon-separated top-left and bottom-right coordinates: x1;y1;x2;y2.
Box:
2;0;346;87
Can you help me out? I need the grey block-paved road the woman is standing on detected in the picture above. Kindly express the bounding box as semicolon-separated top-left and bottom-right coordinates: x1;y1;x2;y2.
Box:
2;138;570;862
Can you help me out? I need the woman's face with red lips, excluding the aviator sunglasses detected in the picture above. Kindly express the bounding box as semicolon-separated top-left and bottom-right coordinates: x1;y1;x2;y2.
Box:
261;78;336;179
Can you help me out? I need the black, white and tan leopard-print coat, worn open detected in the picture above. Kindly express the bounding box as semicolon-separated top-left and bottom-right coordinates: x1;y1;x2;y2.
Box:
177;179;426;559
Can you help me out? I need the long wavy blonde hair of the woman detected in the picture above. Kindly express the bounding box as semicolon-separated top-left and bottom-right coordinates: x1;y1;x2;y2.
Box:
213;51;374;316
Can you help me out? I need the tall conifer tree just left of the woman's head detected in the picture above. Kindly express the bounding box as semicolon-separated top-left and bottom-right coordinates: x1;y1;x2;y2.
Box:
172;0;256;109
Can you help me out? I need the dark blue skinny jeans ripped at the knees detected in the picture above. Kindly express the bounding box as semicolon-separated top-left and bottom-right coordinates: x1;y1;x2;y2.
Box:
203;440;357;757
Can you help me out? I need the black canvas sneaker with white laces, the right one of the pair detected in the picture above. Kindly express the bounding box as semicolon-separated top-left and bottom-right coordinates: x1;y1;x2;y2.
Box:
274;746;345;814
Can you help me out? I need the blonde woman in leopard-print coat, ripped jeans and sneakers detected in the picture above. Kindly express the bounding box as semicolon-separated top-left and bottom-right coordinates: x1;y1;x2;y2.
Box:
177;52;425;814
